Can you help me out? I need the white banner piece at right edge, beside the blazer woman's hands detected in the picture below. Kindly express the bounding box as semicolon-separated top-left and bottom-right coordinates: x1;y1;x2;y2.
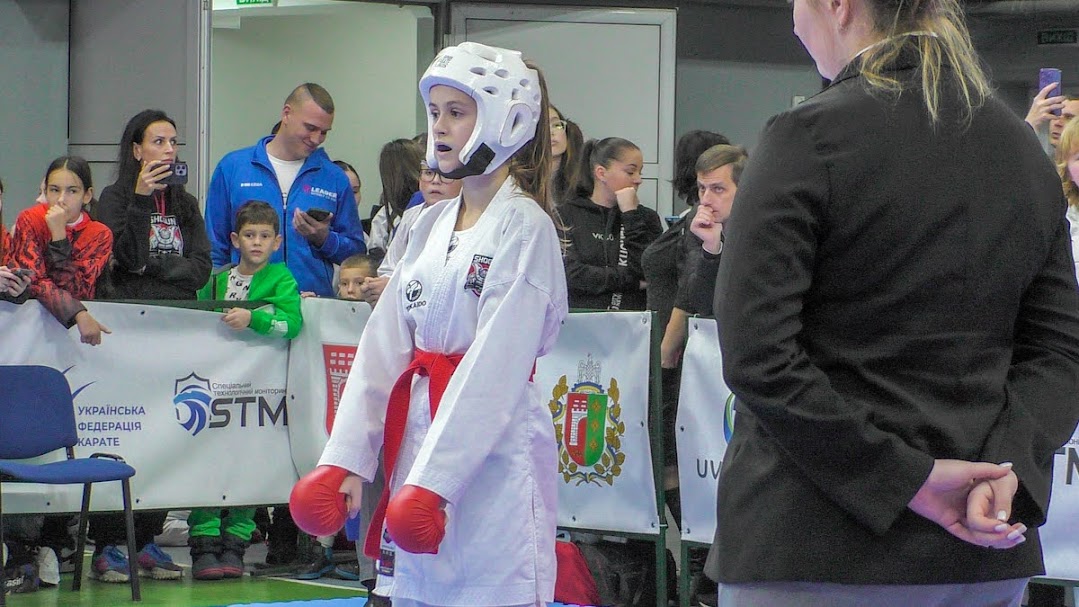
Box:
1039;431;1079;580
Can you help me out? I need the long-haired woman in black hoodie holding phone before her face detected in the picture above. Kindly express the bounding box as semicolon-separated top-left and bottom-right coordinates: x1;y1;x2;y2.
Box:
95;110;210;300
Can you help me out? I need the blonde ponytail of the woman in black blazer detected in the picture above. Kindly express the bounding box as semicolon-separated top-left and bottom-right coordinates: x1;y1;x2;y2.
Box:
861;0;991;124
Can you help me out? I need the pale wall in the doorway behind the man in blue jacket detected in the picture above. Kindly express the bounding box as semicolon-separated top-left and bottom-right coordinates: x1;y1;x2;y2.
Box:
210;2;427;217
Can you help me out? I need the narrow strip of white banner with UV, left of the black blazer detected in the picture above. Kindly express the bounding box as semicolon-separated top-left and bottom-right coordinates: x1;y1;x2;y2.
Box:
674;318;734;543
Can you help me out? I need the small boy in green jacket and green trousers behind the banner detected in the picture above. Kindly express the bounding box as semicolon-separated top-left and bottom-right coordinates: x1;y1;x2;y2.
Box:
188;201;303;580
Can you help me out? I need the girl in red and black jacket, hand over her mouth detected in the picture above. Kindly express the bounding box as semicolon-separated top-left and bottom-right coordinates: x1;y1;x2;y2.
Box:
11;156;112;346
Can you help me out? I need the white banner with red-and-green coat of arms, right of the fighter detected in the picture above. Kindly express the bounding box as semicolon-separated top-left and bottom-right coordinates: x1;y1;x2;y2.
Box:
535;313;659;534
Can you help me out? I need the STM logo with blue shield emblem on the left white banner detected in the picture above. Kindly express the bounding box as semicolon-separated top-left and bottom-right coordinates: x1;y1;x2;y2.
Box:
173;371;288;437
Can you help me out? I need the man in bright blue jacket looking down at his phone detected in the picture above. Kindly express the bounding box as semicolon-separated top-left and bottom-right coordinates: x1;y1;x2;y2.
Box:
206;82;367;296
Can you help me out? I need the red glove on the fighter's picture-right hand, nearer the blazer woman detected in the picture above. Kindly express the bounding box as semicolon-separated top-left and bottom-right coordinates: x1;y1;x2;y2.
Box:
388;485;446;554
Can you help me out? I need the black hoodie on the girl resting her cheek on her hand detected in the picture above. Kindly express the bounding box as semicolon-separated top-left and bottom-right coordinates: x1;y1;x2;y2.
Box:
558;197;663;309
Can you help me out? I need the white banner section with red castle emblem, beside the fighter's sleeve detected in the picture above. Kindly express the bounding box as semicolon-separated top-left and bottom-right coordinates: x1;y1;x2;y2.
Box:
288;298;371;475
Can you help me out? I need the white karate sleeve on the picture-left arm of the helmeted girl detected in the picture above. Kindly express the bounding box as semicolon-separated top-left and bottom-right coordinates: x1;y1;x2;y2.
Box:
318;268;413;481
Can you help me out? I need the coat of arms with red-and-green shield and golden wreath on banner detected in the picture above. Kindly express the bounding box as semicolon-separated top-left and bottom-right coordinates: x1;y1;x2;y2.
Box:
549;355;626;485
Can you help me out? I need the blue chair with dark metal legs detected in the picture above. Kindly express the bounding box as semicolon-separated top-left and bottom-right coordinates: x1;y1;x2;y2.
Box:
0;365;141;606
